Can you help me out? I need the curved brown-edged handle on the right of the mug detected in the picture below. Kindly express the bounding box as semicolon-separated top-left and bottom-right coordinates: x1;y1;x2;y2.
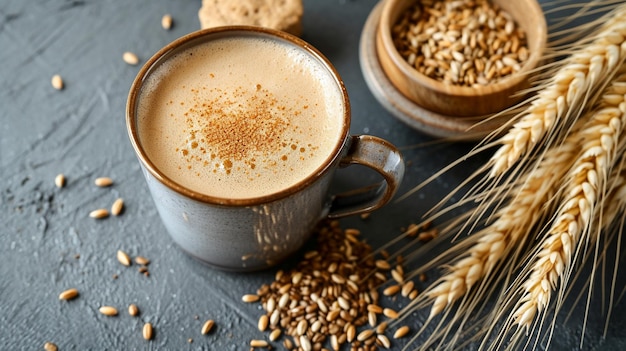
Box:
327;135;404;218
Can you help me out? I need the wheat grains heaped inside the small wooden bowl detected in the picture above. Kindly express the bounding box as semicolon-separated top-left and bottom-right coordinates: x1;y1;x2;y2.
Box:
391;0;529;87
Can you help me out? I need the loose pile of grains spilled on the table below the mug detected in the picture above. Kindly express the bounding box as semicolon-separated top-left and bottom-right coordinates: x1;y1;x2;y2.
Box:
242;221;417;351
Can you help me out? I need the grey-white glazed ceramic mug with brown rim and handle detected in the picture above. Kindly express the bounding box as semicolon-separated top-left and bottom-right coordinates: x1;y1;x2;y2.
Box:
126;26;404;271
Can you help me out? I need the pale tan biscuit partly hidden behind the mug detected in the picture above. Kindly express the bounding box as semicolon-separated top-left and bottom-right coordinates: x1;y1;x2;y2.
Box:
198;0;303;36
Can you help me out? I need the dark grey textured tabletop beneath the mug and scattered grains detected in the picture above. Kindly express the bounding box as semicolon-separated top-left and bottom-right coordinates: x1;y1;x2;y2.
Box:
0;0;626;350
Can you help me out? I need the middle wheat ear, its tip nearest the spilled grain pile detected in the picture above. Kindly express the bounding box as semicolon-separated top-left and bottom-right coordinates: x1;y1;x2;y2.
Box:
422;135;578;318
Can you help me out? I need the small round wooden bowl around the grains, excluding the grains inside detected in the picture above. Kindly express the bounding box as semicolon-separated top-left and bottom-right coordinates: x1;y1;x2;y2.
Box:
376;0;547;117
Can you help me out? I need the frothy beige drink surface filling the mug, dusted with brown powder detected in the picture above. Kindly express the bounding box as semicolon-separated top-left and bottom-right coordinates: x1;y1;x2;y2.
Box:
137;37;344;199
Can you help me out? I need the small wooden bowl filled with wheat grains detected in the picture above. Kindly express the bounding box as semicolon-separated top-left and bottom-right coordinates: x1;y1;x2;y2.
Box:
376;0;547;117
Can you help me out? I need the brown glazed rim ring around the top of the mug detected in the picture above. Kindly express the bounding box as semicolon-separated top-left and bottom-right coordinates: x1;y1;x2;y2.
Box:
126;26;350;206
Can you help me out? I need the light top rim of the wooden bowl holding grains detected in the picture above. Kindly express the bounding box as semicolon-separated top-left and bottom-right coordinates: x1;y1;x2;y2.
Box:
378;0;548;97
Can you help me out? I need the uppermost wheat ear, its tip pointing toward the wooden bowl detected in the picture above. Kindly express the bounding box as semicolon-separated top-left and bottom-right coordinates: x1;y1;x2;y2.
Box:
489;4;626;177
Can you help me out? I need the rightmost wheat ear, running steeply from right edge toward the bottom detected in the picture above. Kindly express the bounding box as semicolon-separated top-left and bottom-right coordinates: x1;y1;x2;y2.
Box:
512;76;626;331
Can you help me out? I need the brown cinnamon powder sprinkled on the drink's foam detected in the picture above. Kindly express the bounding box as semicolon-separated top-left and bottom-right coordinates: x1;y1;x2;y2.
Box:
174;84;317;177
